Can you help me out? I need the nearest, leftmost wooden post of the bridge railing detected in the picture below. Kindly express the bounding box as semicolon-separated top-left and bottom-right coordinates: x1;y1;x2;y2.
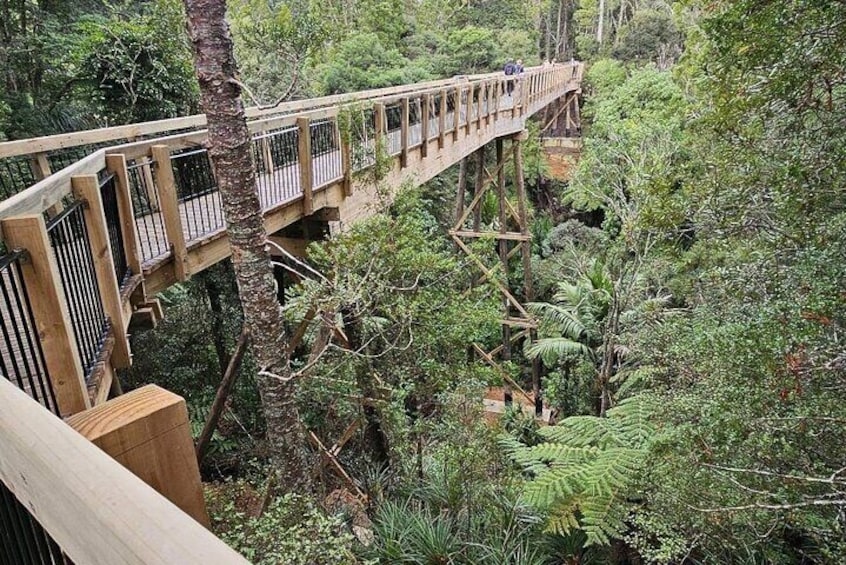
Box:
2;214;91;416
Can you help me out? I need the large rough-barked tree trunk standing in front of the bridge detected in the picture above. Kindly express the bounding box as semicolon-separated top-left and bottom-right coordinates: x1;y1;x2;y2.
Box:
183;0;311;491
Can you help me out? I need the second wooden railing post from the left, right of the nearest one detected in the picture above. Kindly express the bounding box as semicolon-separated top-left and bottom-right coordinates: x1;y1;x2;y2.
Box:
71;175;132;369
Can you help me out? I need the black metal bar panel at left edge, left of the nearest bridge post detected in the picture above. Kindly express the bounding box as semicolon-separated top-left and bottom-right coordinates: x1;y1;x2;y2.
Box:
0;251;59;415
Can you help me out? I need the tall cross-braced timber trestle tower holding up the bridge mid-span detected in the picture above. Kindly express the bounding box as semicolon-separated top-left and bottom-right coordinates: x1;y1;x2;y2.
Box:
449;131;543;416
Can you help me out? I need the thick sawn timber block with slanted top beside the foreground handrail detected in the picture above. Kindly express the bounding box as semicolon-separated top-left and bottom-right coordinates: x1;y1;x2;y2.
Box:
67;385;209;527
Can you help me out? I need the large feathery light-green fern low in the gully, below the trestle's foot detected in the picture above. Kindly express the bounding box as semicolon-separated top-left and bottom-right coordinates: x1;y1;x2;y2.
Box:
502;395;655;545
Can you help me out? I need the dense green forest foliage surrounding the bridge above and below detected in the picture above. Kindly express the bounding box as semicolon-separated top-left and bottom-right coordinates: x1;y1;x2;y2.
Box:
6;0;846;564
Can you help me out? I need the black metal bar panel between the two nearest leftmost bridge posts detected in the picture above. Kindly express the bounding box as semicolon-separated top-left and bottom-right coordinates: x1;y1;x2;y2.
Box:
47;200;109;379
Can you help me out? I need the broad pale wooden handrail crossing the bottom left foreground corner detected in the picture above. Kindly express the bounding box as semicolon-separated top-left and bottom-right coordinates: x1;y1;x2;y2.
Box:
0;379;248;565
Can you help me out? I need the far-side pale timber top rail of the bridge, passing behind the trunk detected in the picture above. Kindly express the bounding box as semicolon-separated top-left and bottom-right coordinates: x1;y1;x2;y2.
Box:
0;63;578;159
